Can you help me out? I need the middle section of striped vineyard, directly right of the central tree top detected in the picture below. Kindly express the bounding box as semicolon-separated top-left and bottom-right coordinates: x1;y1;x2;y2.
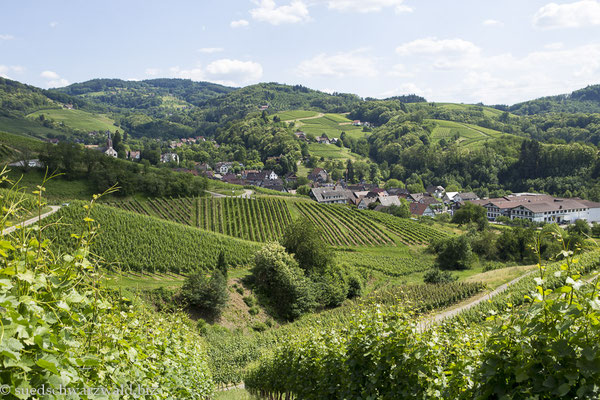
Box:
296;202;395;246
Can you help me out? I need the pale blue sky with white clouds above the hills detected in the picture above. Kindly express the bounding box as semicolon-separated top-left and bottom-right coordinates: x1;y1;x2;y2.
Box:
0;0;600;104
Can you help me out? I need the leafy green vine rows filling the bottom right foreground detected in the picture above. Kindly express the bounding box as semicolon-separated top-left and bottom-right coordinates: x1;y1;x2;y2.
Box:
245;231;600;400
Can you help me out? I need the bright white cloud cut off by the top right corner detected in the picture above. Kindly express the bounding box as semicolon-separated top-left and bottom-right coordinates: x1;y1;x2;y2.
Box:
533;0;600;29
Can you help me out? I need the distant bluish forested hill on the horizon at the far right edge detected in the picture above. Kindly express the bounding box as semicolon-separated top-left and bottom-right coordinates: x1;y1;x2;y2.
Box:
500;85;600;115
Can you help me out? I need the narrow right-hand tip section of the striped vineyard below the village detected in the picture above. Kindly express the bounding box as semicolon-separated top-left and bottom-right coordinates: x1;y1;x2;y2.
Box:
360;210;447;245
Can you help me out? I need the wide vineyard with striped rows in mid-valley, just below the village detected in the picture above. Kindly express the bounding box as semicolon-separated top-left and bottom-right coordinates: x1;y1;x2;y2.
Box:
105;197;448;250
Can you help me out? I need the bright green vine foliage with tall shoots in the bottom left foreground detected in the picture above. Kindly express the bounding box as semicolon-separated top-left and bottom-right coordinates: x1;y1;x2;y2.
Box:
0;177;213;399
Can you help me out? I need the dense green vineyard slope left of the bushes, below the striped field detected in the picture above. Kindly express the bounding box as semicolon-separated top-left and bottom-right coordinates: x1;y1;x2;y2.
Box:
44;201;258;274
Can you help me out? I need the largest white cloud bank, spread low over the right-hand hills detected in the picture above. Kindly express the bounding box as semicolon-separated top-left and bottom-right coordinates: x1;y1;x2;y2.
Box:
388;36;600;104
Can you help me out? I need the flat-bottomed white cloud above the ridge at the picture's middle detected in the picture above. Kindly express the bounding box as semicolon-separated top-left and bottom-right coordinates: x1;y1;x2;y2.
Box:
296;50;377;78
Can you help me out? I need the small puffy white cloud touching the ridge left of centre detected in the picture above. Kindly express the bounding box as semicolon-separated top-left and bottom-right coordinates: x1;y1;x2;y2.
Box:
206;58;263;86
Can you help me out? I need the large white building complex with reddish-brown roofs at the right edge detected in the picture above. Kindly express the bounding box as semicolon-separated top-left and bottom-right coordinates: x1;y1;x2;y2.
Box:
470;193;600;224
